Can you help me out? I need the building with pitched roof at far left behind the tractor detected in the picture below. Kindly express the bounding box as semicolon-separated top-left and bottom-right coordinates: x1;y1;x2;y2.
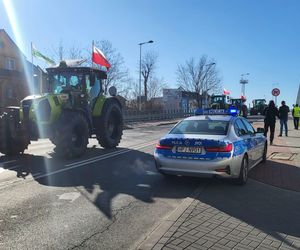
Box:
0;29;47;109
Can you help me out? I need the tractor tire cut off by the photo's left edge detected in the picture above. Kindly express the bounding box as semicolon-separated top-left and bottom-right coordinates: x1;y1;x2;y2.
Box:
0;110;30;156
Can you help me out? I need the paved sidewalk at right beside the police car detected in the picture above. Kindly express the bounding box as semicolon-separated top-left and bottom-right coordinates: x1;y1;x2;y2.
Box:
139;118;300;250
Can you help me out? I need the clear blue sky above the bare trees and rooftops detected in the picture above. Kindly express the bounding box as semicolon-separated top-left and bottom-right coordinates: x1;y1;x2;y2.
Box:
0;0;300;105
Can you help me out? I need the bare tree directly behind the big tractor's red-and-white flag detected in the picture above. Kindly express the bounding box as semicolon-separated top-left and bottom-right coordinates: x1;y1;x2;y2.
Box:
95;40;129;94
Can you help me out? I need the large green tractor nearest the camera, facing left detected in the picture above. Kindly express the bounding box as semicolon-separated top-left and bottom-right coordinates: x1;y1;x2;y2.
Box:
0;61;123;159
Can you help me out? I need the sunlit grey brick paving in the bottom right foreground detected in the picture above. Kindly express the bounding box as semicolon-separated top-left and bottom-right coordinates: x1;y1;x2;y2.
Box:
153;196;300;250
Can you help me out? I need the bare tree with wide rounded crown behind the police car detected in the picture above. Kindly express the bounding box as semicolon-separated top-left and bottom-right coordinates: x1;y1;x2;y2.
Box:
176;56;221;107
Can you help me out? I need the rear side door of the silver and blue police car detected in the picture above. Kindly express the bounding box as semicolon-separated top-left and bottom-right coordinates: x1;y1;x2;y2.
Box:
234;117;255;167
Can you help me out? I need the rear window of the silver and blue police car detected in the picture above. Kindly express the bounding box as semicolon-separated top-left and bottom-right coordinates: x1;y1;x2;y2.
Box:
170;120;229;135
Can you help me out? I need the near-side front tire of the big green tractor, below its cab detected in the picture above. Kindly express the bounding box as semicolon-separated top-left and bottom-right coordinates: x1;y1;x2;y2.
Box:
52;112;89;159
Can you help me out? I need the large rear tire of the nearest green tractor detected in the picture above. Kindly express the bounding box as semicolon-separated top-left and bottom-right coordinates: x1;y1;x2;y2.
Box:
96;99;123;148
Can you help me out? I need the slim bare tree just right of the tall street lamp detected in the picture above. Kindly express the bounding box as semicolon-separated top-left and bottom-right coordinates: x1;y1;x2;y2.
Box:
141;51;158;100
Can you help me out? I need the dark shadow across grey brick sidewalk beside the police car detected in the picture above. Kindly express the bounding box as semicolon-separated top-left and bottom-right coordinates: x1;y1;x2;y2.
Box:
198;180;300;247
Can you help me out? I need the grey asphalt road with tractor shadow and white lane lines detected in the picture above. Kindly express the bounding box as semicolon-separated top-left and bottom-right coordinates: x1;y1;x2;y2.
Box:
0;125;210;249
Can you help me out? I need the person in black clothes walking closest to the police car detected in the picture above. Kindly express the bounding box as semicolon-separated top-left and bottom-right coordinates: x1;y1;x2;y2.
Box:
263;100;279;145
